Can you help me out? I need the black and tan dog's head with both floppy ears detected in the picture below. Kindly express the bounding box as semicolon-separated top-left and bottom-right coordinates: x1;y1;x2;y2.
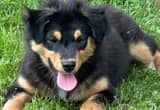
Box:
23;0;107;91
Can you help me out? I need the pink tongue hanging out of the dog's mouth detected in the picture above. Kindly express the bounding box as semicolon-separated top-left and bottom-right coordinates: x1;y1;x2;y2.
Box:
57;72;77;91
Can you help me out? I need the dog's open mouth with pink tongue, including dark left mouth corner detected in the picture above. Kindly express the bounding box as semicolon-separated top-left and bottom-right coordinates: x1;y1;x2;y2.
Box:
48;59;78;91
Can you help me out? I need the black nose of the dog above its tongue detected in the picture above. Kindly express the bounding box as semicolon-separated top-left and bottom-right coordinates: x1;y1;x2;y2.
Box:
62;61;75;72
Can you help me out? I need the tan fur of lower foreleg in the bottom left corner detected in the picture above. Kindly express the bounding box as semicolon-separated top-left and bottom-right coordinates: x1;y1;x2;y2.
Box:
2;93;32;110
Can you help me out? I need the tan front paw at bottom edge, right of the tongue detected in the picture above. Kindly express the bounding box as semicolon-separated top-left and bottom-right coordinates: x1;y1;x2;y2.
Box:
80;95;105;110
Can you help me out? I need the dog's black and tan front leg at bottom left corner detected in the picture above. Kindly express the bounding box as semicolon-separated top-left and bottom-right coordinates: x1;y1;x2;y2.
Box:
2;77;35;110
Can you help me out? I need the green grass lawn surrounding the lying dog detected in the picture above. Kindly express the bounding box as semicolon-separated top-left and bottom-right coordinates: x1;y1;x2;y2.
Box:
0;0;160;110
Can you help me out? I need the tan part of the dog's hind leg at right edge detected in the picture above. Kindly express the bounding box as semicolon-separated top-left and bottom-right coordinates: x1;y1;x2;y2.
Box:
129;40;160;70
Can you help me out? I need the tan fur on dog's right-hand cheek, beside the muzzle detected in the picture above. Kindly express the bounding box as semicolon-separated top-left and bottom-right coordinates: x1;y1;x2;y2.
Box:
74;37;96;71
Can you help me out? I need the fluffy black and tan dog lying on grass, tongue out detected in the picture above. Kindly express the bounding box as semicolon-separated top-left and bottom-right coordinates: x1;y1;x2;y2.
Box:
3;0;160;110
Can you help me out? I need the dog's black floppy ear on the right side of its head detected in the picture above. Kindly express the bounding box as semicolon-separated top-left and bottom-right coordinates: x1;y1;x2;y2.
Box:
84;8;109;44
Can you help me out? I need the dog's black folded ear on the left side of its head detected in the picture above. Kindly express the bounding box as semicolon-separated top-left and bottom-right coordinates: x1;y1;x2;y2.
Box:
22;7;54;43
